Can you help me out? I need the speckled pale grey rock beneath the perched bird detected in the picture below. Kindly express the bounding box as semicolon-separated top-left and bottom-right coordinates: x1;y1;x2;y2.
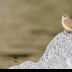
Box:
9;31;72;69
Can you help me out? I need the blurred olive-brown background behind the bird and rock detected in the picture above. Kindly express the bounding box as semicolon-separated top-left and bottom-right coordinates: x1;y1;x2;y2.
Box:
0;0;72;69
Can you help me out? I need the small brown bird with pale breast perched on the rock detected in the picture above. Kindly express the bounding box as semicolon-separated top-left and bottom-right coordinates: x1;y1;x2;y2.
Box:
59;14;72;33
